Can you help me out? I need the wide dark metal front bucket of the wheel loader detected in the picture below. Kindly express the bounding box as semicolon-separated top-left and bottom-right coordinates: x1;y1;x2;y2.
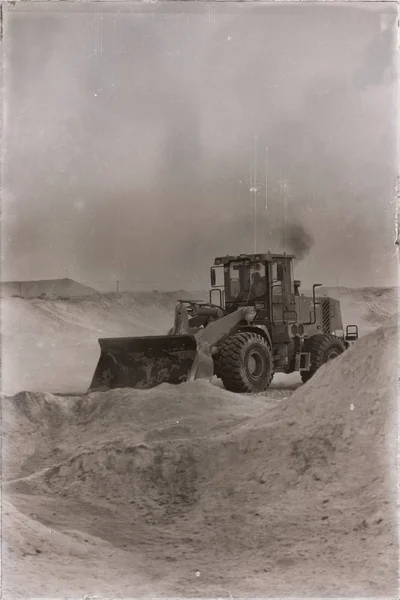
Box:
89;335;197;391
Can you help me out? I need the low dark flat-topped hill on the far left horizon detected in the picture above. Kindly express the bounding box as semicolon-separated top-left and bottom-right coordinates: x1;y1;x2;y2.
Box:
0;278;98;299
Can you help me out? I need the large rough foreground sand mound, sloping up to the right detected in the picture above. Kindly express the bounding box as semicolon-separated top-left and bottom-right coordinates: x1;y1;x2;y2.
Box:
3;316;398;597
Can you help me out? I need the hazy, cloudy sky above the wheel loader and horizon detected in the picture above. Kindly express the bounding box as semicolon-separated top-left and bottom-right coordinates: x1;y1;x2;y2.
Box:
2;2;397;287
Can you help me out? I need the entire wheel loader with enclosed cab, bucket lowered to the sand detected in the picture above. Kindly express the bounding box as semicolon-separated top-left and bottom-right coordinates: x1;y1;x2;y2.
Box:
89;252;358;393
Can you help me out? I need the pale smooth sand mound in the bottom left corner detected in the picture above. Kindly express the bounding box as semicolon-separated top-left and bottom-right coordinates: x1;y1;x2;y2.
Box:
2;500;156;598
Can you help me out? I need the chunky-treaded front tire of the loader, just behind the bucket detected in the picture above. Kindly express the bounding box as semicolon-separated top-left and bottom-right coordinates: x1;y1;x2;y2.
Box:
215;331;274;394
